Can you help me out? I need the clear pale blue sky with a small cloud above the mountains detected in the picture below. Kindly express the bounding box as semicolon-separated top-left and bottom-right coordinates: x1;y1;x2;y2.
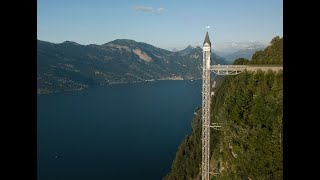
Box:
37;0;283;50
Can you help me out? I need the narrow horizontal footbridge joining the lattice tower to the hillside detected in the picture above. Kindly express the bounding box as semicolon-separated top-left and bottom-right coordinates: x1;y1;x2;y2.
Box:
210;64;282;75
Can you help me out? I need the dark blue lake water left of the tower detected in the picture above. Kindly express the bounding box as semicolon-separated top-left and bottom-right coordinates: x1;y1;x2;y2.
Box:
37;80;201;180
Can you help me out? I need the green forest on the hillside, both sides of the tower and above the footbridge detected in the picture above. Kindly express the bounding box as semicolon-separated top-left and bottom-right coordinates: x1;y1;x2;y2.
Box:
164;36;283;180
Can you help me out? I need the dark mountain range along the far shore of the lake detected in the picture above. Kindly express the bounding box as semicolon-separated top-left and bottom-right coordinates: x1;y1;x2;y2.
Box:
37;39;226;94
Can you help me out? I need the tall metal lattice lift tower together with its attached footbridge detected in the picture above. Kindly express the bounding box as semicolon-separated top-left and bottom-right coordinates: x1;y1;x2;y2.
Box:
201;32;282;180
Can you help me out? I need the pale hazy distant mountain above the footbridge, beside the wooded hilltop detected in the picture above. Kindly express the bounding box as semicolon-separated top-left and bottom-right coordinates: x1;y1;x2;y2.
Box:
224;46;265;63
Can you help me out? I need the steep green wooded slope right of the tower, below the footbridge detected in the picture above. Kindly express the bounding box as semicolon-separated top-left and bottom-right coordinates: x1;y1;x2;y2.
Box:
211;72;283;179
